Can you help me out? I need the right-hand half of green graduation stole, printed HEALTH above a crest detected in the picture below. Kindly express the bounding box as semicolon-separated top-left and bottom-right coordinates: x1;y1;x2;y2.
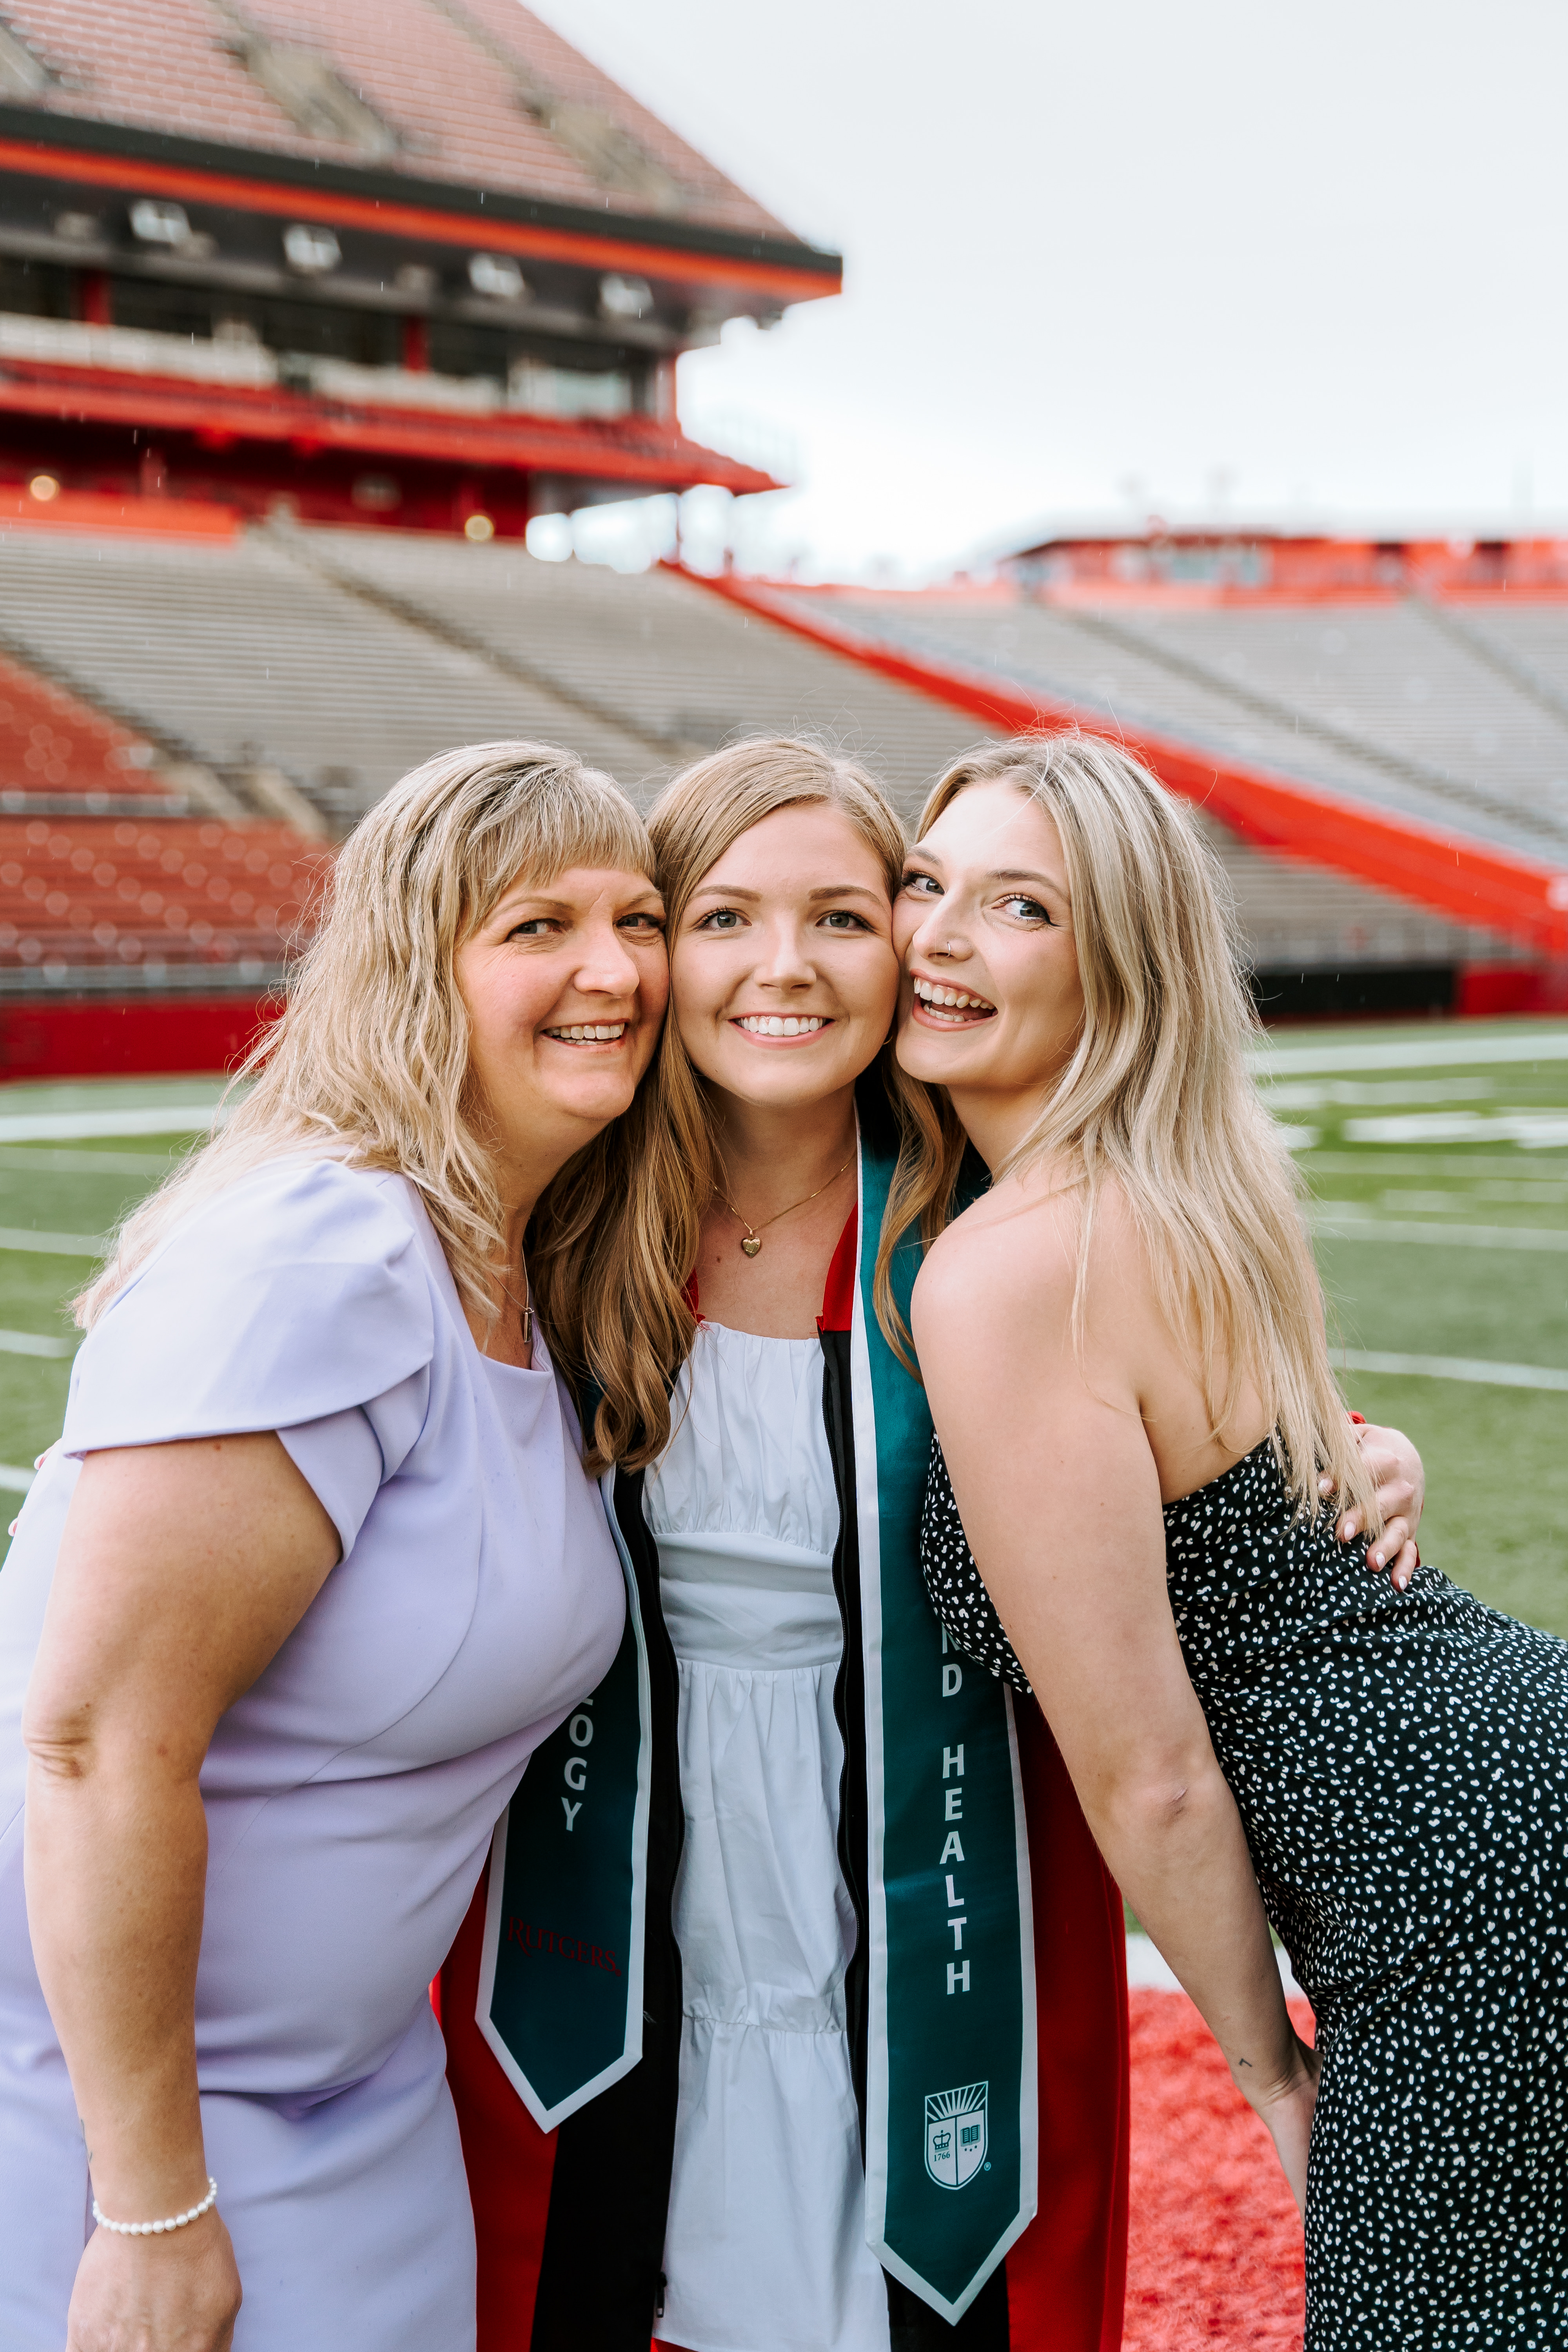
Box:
851;1129;1039;2321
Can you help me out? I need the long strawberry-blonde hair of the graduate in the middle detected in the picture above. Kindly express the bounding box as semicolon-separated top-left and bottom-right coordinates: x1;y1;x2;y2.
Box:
529;736;919;1468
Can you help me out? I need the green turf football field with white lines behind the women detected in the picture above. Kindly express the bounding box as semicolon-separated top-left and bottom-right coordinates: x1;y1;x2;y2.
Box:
0;1021;1568;1635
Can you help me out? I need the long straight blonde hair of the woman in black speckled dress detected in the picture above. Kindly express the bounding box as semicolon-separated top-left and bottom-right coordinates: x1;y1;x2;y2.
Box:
882;734;1380;1534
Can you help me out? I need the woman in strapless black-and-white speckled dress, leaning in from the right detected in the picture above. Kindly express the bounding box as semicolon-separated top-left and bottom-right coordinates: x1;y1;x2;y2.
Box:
896;736;1568;2352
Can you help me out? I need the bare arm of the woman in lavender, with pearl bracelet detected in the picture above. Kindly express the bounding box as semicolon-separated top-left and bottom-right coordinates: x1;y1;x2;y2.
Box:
24;1432;339;2352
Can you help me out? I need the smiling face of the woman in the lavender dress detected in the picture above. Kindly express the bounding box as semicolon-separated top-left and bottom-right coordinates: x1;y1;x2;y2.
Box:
454;868;670;1197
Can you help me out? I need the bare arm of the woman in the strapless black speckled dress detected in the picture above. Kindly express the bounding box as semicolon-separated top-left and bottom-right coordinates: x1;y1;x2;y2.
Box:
915;1209;1316;2201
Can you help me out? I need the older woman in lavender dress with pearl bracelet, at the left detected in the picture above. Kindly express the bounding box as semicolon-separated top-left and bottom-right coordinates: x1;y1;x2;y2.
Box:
0;743;668;2352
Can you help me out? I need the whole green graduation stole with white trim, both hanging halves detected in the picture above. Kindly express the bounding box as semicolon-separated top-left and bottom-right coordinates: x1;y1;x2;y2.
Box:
477;1131;1039;2321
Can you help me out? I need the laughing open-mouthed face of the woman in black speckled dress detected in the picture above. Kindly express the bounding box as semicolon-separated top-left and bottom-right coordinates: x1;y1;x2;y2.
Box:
893;781;1084;1164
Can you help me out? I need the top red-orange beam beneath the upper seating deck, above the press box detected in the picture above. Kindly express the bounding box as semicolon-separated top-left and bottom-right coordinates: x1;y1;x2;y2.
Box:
0;360;780;496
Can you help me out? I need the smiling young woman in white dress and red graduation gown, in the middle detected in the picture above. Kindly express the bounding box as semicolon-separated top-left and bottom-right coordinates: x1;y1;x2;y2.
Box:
442;741;1420;2352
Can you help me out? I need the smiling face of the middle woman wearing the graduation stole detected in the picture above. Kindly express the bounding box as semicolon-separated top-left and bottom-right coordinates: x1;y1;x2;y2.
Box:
670;802;898;1108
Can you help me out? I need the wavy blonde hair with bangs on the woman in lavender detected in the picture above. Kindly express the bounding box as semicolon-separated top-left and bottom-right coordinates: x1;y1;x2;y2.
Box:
75;743;653;1324
